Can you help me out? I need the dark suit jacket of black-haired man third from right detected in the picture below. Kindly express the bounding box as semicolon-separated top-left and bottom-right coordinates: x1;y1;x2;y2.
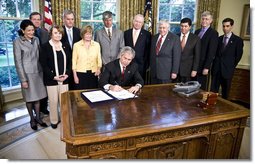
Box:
178;32;201;77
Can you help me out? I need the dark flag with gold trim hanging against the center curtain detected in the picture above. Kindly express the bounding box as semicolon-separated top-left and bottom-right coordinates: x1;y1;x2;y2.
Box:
144;0;152;33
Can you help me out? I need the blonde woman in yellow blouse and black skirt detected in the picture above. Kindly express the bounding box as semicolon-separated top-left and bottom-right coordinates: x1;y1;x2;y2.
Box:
72;25;102;89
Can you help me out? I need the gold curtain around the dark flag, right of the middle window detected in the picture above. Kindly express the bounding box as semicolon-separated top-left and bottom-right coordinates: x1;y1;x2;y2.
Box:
119;0;158;33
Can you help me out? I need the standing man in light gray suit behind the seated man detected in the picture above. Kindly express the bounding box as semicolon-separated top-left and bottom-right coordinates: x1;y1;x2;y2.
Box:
95;11;125;65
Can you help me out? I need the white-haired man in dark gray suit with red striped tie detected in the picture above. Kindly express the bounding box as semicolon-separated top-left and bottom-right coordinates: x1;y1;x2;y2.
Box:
150;20;181;84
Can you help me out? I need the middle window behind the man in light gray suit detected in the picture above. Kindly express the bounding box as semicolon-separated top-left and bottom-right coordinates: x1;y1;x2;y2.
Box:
81;0;117;31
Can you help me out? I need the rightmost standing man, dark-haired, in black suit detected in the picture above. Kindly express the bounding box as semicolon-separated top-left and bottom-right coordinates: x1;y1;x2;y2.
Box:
211;18;244;99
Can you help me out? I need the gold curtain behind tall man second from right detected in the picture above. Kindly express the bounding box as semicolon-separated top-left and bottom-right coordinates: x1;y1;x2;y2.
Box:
196;0;221;29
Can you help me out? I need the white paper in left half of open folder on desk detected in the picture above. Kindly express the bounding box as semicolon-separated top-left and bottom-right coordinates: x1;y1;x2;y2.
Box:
81;90;114;103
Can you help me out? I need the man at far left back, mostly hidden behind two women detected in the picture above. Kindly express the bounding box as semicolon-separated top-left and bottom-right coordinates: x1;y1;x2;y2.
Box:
29;12;49;45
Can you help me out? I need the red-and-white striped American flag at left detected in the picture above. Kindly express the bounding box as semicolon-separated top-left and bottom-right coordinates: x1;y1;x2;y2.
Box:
44;0;52;31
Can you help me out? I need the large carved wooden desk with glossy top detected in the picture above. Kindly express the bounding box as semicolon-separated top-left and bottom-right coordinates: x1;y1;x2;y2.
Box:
61;85;249;159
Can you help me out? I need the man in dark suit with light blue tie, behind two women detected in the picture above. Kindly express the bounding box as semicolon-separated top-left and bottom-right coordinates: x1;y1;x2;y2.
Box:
61;10;81;90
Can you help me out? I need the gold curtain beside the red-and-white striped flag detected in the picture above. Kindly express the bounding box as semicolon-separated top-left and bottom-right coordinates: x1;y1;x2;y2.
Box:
40;0;81;27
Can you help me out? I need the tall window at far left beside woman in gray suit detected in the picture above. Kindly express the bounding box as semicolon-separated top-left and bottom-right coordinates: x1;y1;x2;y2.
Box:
0;0;31;90
